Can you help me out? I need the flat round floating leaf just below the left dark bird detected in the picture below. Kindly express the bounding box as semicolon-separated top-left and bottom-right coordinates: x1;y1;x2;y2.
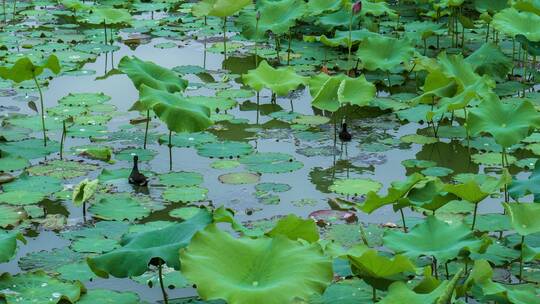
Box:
88;195;150;221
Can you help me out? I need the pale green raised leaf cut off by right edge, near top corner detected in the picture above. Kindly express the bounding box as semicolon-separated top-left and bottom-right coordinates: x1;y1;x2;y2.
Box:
491;8;540;42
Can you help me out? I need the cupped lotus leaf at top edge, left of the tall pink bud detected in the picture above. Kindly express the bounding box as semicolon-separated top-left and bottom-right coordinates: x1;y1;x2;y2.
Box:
237;0;307;39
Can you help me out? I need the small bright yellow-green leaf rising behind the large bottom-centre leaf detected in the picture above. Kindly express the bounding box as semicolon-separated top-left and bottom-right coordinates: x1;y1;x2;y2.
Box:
266;214;319;243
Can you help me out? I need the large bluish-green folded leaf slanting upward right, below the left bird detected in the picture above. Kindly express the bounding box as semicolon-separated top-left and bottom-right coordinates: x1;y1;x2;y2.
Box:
87;212;212;278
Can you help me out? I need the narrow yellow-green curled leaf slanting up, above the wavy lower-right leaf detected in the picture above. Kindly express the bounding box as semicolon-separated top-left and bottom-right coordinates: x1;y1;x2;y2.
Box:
360;173;424;214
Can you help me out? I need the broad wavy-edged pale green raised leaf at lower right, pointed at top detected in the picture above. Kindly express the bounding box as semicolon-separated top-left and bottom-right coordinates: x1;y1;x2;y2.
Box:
383;216;482;263
